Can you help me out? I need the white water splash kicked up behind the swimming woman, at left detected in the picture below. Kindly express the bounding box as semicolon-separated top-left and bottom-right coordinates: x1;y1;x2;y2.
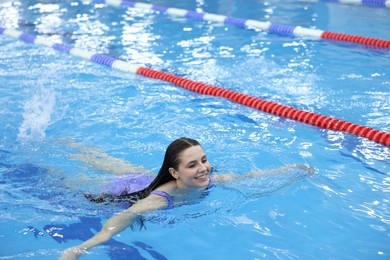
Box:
18;83;56;140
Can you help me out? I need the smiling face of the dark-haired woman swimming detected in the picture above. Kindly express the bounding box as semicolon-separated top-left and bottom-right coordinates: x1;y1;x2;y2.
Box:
170;145;211;188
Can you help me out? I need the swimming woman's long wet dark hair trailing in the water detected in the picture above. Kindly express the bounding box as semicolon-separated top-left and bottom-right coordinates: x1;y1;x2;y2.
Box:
85;137;200;204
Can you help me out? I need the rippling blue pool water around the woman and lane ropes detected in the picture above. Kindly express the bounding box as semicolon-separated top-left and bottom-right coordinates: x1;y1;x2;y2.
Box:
0;0;390;259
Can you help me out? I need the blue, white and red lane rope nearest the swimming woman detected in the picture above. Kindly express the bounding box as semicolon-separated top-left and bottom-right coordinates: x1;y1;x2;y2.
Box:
0;27;390;147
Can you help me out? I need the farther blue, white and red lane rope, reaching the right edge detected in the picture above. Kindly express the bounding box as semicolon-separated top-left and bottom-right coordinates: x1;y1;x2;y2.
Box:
95;0;390;48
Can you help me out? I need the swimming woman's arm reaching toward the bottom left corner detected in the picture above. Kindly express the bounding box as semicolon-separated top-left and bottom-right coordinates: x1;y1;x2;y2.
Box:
60;195;167;260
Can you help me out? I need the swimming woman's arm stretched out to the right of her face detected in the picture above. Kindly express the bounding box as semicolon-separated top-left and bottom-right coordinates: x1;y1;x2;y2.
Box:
214;164;314;182
